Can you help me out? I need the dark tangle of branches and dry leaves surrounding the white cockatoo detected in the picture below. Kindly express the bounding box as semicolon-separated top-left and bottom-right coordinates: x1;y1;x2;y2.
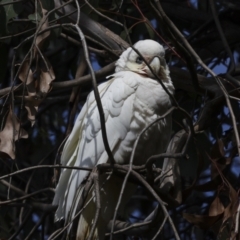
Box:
0;0;240;239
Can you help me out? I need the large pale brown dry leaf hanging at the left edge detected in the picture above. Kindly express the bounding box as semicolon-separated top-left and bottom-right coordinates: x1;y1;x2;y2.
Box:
0;109;28;159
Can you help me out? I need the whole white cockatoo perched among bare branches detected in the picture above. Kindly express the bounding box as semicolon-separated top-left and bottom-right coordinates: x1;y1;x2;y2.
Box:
53;40;174;240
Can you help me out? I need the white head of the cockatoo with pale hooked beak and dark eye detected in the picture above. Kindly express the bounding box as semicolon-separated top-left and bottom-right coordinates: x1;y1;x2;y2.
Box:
115;39;169;81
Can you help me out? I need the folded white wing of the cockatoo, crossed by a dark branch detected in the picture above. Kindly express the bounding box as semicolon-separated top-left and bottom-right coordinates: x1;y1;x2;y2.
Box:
53;71;138;219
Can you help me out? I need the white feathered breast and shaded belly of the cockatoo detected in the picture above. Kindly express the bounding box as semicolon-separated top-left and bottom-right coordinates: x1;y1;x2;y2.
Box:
109;71;173;165
